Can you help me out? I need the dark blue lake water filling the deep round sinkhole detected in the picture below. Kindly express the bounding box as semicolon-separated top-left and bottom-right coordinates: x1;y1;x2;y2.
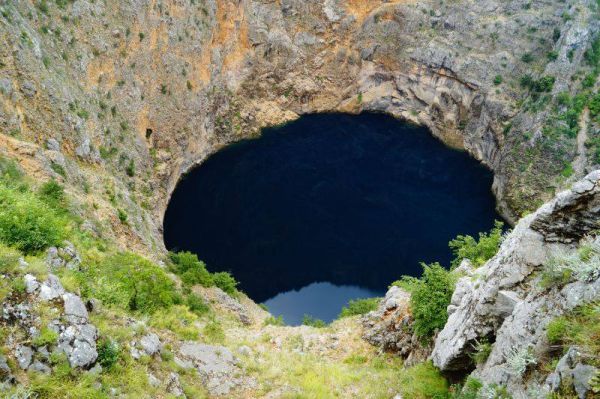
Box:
164;114;500;323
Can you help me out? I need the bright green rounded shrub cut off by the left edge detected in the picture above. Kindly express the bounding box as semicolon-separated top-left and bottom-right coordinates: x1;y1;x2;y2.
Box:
0;186;67;253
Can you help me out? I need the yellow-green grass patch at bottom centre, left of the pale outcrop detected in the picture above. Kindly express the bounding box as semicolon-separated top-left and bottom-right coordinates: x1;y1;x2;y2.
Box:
245;344;448;399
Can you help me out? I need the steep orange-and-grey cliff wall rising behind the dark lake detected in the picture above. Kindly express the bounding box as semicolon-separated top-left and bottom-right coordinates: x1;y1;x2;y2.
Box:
0;0;600;255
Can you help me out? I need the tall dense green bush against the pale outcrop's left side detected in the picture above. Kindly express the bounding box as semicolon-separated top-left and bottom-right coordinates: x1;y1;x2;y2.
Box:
410;263;454;338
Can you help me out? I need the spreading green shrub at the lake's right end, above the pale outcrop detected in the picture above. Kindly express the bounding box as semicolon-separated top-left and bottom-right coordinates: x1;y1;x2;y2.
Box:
448;220;504;267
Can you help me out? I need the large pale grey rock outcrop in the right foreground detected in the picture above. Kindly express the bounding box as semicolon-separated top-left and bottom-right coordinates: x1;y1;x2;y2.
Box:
431;171;600;395
